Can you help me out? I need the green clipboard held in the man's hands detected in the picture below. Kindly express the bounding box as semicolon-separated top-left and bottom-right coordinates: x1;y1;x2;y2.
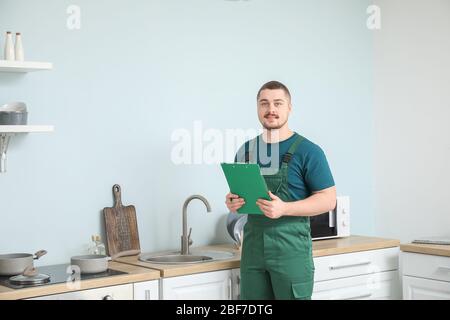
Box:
221;163;271;214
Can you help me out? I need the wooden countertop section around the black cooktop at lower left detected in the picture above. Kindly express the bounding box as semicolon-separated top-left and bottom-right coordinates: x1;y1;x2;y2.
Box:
0;262;160;300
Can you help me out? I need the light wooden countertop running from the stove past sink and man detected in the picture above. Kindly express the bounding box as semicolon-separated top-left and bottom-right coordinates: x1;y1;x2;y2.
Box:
0;236;400;300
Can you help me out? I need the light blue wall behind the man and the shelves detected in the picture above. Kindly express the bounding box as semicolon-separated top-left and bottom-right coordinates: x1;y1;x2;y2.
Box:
0;0;374;264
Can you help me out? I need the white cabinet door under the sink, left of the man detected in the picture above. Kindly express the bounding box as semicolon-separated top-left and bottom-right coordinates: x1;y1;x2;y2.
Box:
161;270;232;300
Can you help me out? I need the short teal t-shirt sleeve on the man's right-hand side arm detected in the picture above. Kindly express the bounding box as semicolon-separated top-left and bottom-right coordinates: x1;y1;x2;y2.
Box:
304;145;335;192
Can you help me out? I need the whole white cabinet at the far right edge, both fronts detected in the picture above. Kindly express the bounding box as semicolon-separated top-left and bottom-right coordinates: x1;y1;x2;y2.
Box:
401;252;450;300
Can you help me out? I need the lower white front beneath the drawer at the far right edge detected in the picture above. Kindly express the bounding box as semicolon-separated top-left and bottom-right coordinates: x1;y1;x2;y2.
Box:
403;276;450;300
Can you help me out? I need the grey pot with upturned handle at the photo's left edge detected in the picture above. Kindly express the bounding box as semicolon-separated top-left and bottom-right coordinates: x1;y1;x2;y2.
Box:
0;250;47;276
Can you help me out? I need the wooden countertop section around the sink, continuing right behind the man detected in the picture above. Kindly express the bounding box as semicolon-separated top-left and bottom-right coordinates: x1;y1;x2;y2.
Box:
117;236;400;278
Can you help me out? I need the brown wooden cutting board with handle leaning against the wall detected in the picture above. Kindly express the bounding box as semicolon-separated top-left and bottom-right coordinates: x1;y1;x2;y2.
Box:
103;184;141;260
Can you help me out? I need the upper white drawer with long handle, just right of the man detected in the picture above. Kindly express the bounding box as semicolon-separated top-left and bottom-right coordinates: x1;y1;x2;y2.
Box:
314;247;399;281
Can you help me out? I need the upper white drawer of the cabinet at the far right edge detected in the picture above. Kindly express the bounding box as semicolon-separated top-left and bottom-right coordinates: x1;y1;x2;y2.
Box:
402;252;450;282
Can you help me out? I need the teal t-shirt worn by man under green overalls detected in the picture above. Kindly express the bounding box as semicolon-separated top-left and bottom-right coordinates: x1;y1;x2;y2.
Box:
235;133;335;200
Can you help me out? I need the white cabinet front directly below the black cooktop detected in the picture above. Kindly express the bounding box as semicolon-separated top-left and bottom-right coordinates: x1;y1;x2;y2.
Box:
29;284;133;300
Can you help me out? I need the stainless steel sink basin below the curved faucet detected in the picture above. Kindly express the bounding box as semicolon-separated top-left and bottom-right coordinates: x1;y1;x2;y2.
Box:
139;249;234;264
